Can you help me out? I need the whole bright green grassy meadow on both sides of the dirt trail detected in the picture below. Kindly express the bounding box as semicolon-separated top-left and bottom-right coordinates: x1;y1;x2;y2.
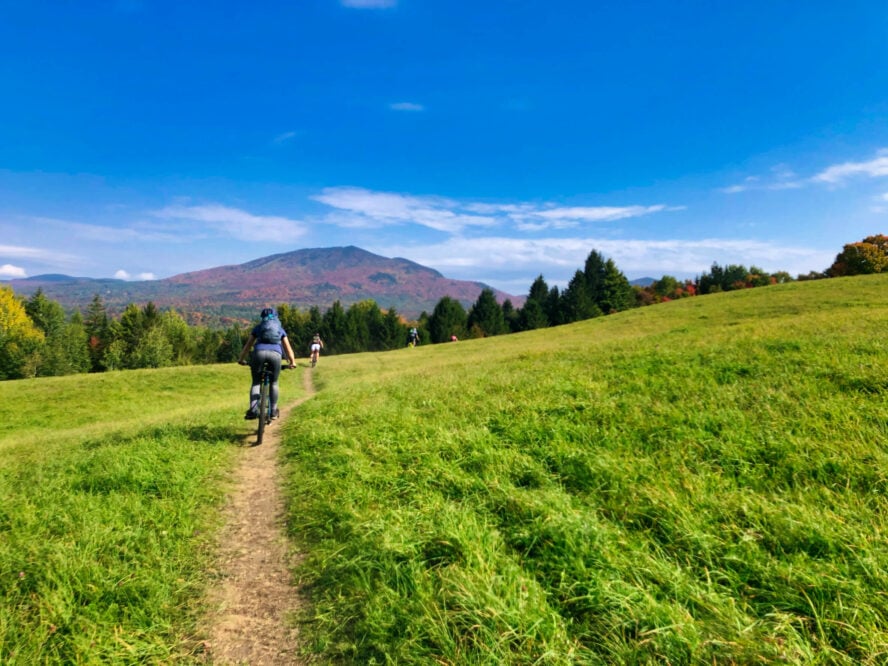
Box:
0;275;888;665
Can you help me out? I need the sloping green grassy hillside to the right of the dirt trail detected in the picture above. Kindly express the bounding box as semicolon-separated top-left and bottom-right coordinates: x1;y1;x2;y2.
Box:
285;275;888;664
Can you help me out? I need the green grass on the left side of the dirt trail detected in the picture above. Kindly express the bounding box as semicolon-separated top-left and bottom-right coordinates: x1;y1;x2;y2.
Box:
0;365;299;665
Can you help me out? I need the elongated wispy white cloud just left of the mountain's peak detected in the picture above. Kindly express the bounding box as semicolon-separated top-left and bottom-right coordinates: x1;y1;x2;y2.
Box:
153;204;306;242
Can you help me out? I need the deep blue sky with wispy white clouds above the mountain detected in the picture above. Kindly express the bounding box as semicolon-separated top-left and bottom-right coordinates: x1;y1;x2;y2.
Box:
0;0;888;295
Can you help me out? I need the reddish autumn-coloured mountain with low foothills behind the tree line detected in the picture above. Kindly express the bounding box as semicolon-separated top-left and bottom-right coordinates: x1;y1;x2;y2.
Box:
10;246;524;323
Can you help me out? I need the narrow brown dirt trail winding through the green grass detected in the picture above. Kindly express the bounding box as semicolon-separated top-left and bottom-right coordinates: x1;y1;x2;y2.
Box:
204;369;314;666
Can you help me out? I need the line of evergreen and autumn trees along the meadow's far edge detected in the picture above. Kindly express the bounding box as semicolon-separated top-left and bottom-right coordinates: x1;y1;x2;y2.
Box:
0;235;888;379
